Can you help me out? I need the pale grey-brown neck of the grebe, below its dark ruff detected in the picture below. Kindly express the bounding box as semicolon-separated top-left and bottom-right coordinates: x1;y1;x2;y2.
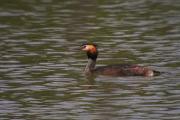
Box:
85;58;96;74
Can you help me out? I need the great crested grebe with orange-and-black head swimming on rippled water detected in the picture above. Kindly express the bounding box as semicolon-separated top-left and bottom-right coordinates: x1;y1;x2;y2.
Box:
82;43;160;77
